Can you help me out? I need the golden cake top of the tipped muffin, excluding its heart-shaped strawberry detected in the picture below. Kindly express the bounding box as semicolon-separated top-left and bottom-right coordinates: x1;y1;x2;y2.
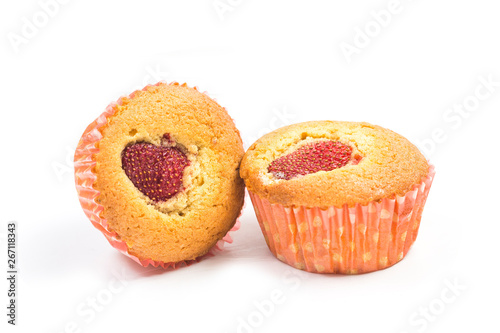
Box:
93;84;244;262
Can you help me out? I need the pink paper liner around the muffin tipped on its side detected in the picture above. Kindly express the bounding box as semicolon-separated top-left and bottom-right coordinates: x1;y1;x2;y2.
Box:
74;82;241;269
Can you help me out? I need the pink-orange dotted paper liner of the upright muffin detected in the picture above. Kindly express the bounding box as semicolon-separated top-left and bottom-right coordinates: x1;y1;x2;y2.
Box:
249;165;435;274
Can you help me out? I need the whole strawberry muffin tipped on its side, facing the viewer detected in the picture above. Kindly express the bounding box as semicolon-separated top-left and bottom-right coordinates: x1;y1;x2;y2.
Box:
75;83;244;267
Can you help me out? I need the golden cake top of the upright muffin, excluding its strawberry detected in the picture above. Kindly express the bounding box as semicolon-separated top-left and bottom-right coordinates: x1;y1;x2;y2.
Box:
240;121;429;208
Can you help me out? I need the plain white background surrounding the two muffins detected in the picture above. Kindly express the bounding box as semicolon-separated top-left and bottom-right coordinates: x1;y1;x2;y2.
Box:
0;0;500;333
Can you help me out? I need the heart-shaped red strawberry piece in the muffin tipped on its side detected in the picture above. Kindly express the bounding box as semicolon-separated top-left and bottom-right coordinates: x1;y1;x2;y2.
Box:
122;138;189;202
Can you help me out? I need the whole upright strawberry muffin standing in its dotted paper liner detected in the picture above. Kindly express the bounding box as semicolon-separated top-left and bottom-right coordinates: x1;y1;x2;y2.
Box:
240;121;435;274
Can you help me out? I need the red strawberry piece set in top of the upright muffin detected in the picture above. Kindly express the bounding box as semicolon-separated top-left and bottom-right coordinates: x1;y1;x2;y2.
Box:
268;141;359;180
